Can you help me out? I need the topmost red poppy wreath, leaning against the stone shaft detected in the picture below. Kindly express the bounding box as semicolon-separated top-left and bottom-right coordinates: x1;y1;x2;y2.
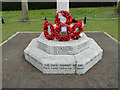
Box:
55;10;72;25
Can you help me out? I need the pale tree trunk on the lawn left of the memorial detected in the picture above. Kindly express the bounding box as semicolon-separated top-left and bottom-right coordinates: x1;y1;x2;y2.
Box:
21;0;29;21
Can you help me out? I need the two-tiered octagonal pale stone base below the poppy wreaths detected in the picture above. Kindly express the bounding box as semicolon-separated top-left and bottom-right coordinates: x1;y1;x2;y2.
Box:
24;33;103;74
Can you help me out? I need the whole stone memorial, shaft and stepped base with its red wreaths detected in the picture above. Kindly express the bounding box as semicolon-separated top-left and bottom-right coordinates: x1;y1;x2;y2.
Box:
24;0;103;74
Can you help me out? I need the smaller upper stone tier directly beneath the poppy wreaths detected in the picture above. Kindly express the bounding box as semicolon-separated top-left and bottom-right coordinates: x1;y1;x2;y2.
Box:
38;33;89;55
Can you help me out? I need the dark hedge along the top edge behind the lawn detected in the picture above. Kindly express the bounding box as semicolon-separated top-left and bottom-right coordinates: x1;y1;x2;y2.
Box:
2;2;116;11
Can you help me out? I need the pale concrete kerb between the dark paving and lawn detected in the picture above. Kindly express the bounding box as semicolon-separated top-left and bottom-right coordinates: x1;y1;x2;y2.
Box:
0;31;120;47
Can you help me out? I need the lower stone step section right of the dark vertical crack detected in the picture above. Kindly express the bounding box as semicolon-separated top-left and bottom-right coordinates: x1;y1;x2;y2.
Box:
75;39;103;74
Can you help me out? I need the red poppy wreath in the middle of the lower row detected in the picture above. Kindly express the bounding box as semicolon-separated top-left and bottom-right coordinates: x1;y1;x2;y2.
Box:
55;23;71;41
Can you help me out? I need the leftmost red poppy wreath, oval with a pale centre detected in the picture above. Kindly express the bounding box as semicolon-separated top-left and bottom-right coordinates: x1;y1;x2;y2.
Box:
43;20;55;40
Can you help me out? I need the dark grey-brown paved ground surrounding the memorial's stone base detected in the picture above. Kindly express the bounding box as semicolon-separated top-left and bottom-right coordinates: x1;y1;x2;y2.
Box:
2;32;118;88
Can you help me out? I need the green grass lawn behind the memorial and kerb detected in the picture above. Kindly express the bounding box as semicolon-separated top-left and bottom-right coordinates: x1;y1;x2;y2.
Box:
2;7;118;41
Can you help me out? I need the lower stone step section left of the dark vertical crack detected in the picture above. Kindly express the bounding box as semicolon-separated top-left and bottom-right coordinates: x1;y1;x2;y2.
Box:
24;39;75;74
